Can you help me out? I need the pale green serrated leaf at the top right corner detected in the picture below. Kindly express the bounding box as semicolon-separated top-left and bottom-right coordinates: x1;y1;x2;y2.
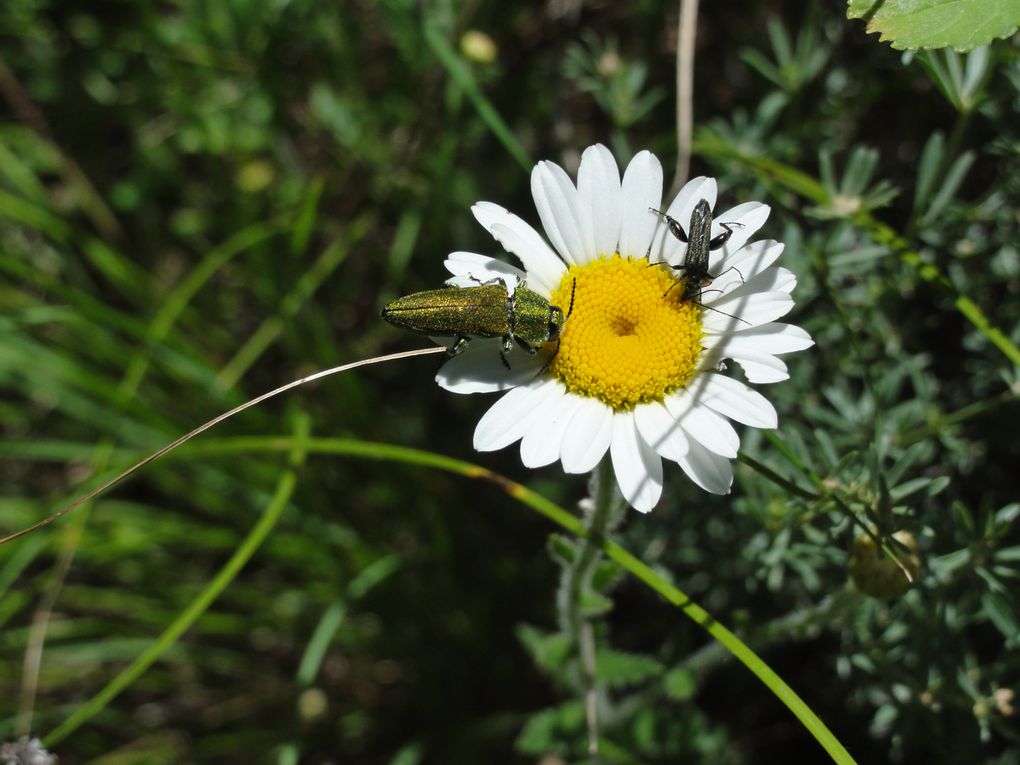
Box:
847;0;1020;51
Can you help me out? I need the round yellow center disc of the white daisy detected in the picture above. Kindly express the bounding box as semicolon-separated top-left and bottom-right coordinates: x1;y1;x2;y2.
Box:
549;254;702;411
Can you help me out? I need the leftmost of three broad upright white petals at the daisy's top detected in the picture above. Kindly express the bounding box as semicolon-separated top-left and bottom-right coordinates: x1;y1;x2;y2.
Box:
531;161;596;265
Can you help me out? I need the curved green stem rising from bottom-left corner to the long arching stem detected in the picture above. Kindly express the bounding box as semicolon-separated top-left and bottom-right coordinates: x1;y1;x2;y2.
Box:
43;415;308;749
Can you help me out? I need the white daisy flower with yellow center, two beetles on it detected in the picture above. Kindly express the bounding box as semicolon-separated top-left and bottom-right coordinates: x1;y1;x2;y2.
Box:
437;145;812;512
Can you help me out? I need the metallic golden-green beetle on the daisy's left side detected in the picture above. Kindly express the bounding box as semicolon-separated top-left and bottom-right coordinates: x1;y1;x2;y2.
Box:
383;281;573;368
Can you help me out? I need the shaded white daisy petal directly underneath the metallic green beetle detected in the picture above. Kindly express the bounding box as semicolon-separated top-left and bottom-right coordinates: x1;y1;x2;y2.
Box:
436;338;546;394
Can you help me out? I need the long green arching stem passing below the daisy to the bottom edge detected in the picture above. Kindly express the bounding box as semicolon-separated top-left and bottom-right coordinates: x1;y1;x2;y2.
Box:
167;437;856;765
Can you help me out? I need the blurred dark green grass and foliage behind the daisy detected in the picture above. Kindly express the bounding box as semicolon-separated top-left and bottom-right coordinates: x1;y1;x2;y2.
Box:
0;0;1020;765
